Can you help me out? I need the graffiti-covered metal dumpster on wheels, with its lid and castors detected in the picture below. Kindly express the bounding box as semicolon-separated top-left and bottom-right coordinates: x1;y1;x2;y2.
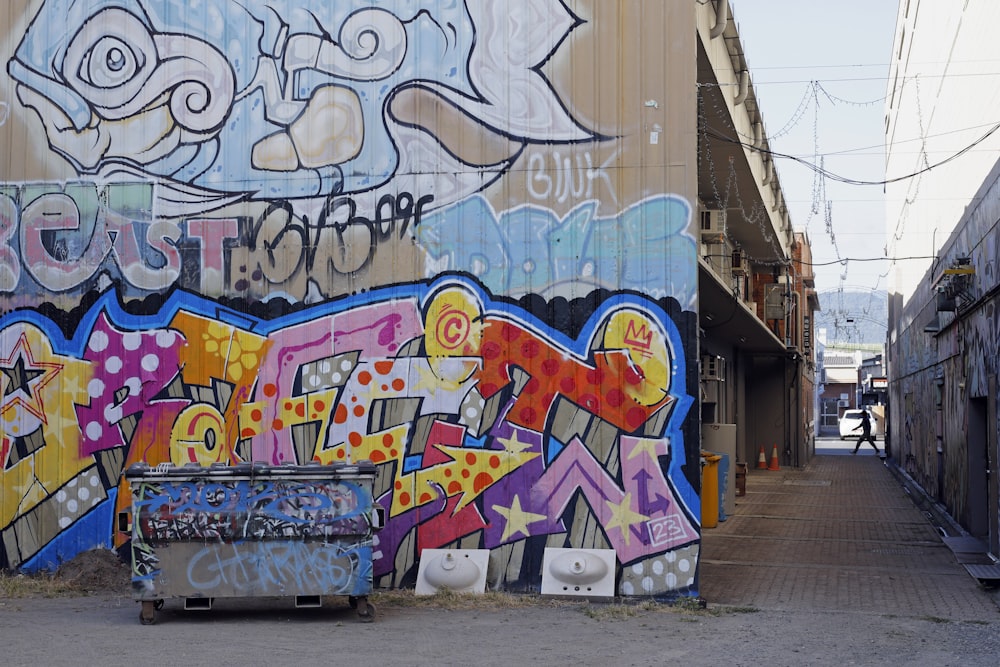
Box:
125;461;384;624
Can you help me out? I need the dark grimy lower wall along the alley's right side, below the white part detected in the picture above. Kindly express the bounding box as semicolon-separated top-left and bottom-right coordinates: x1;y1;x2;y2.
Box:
890;167;1000;531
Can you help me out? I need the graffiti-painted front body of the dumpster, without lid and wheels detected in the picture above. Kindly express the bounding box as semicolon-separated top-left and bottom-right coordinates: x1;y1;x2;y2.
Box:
131;478;372;596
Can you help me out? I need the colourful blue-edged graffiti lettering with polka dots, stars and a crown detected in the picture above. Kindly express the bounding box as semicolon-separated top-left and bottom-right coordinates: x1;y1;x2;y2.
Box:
0;277;699;592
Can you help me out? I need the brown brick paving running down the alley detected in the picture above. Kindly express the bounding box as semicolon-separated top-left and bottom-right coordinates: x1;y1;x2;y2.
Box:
699;453;1000;621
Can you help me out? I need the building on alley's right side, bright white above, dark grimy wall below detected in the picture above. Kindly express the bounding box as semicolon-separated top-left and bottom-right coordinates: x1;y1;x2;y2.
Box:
886;0;1000;556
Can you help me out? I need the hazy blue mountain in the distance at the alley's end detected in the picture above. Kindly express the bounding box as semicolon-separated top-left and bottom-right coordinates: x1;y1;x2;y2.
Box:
815;290;888;345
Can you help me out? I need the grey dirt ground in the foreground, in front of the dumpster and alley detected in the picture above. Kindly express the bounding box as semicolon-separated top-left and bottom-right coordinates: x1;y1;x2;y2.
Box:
0;551;1000;667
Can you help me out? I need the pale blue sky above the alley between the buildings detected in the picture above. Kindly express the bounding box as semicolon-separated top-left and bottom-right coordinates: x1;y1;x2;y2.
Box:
730;0;897;310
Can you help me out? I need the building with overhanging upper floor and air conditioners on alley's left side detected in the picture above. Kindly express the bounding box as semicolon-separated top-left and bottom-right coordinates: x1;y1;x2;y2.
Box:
697;1;819;474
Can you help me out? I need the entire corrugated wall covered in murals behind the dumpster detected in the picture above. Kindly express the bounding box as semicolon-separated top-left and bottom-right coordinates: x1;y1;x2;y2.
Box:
0;0;700;595
